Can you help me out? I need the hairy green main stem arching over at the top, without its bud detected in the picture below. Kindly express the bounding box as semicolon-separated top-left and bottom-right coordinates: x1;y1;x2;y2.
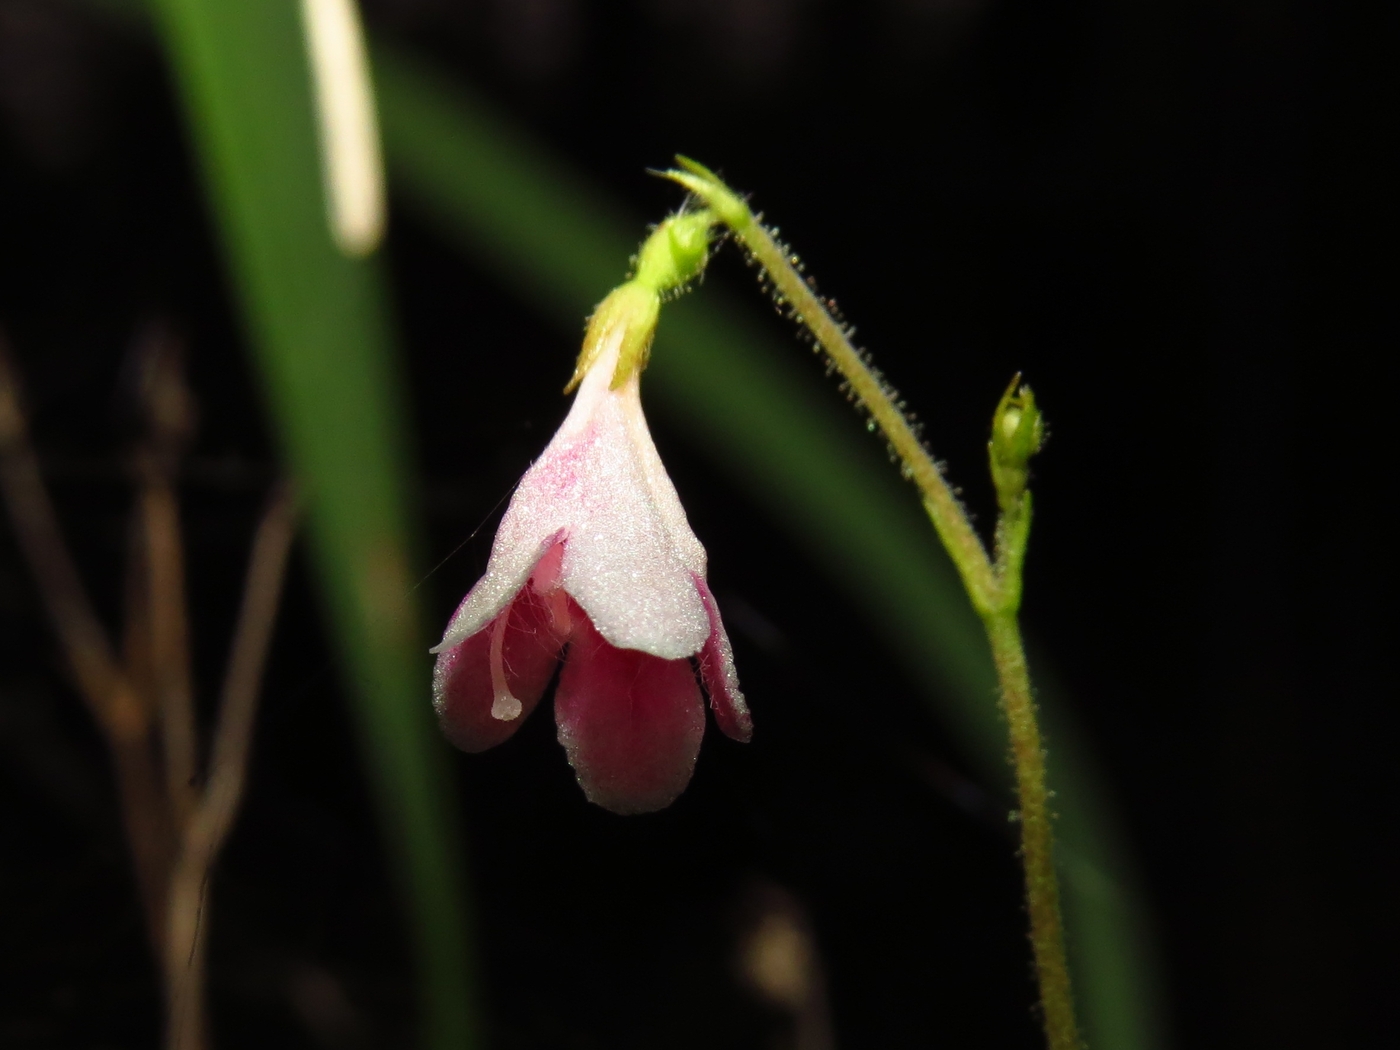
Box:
665;158;1082;1050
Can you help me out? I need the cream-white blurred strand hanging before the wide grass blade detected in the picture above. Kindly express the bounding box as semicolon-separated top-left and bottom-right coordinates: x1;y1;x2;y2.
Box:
301;0;385;258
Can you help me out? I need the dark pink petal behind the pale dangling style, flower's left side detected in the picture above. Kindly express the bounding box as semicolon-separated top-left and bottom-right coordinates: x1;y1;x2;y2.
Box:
433;584;564;752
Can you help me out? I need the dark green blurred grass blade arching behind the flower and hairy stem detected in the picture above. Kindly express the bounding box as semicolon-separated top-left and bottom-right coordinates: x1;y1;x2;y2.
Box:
375;49;1162;1050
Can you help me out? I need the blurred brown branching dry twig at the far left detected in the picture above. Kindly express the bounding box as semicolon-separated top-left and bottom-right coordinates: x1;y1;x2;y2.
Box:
0;325;297;1050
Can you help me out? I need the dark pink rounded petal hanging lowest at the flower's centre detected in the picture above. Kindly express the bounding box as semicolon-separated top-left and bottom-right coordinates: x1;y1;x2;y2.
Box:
554;605;704;813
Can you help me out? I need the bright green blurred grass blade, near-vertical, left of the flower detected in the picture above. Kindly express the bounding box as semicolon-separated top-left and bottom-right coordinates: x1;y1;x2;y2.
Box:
154;8;476;1050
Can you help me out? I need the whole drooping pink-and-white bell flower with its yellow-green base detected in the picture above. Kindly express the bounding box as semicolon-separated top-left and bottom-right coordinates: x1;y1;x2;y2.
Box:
433;213;752;813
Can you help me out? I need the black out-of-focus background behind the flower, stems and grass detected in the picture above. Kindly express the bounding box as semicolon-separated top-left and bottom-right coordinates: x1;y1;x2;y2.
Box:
0;0;1400;1047
